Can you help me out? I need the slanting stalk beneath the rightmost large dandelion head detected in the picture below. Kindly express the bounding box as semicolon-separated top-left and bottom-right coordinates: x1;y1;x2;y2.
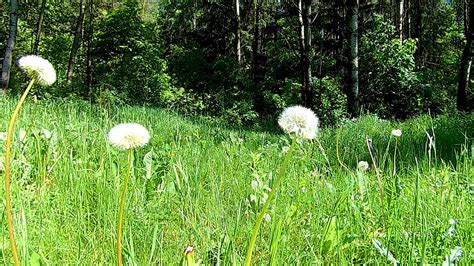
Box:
245;136;296;266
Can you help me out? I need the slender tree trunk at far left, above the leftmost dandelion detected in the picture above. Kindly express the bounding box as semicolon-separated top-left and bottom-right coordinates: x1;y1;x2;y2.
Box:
2;0;18;93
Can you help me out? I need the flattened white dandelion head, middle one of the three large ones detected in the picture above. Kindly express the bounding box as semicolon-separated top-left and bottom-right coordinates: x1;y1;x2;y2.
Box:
108;123;150;150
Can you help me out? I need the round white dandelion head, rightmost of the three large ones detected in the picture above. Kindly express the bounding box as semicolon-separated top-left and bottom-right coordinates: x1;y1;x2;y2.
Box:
278;106;319;139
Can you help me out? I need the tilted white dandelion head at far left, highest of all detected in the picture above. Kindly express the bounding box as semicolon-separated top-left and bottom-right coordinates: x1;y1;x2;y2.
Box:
18;55;56;86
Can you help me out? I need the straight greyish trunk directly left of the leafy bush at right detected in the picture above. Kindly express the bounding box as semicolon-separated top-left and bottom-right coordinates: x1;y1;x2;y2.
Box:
347;0;359;117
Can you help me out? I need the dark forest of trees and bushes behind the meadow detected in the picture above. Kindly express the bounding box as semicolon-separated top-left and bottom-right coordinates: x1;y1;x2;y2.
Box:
0;0;474;126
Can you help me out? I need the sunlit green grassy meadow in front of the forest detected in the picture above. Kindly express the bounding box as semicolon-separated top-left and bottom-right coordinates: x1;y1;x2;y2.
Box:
0;99;474;265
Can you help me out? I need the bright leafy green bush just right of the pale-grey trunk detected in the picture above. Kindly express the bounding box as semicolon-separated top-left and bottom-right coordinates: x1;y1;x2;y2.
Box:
360;16;423;118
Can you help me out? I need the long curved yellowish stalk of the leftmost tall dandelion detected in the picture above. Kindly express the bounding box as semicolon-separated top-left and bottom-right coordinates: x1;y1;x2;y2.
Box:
5;78;36;266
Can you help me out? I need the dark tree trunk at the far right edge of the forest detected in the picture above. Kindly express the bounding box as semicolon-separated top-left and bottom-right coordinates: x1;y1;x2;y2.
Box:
456;1;474;112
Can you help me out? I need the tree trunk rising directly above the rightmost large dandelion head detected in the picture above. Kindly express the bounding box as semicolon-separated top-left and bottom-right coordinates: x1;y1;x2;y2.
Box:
298;0;313;107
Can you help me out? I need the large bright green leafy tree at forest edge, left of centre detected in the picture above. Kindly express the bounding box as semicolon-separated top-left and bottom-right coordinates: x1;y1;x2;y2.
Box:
93;1;173;105
